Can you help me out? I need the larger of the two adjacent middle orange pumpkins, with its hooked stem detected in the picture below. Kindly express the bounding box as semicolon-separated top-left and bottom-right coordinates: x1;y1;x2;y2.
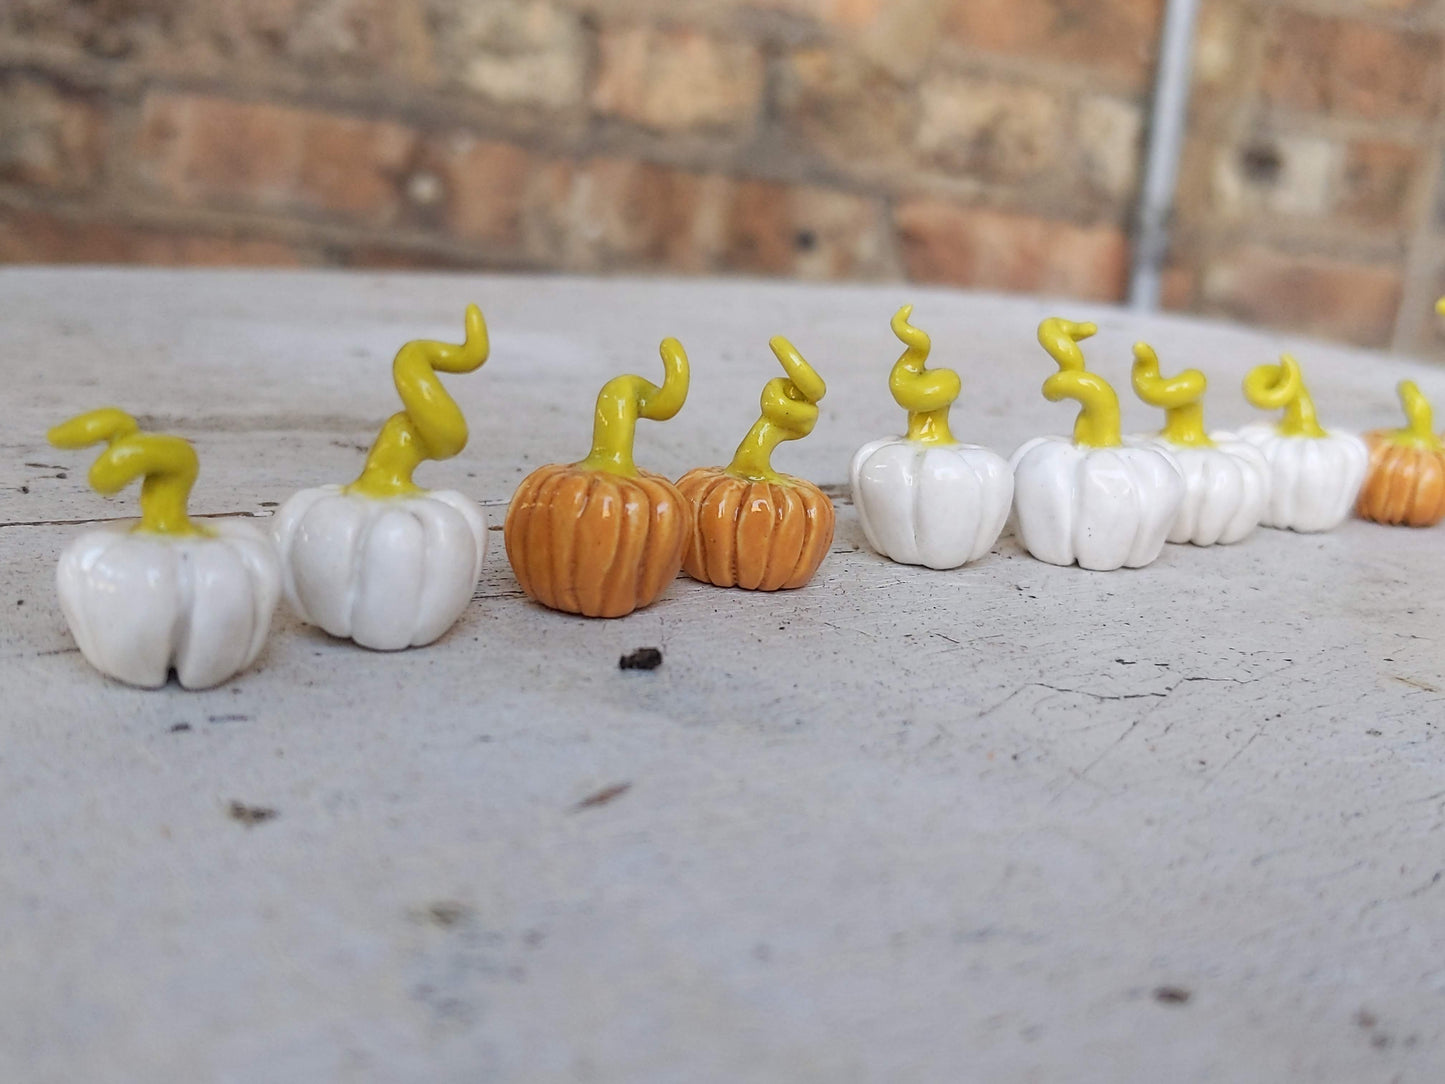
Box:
503;338;691;617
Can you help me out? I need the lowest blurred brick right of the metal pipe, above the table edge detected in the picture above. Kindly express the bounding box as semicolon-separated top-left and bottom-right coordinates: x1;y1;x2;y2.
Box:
1204;246;1402;345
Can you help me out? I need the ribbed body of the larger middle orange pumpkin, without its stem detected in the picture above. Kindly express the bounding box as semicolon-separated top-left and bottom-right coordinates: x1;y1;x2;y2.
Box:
503;464;689;617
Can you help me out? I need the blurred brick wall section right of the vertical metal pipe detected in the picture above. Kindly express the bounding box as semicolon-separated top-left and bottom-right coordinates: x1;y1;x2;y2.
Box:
1168;0;1445;354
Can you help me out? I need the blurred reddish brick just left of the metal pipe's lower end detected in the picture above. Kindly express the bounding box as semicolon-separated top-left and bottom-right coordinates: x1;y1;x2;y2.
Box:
894;199;1129;301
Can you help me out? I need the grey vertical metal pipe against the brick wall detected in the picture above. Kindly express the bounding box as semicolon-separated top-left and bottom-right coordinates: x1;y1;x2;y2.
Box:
1129;0;1199;312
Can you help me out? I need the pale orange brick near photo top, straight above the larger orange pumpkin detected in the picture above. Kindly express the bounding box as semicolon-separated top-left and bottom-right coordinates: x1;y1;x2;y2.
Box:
592;26;763;132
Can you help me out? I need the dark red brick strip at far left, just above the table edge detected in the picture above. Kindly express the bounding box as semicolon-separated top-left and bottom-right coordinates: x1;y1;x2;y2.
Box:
0;211;316;267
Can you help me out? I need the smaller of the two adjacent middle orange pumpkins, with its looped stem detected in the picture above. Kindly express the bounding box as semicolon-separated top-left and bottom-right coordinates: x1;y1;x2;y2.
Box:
678;335;834;591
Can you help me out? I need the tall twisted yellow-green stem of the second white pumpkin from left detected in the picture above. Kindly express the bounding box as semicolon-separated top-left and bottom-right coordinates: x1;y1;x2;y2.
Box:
345;305;491;497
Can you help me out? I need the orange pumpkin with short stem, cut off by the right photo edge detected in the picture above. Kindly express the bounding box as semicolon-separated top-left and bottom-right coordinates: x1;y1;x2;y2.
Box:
1355;380;1445;528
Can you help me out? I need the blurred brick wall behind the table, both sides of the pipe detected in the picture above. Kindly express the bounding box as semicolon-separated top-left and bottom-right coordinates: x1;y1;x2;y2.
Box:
0;0;1445;354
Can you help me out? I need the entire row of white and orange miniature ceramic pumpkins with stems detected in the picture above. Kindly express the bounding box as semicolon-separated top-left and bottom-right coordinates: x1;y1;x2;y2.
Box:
51;305;1445;688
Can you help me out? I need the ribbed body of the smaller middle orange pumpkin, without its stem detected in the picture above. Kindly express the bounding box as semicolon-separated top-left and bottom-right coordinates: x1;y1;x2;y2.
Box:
678;467;835;591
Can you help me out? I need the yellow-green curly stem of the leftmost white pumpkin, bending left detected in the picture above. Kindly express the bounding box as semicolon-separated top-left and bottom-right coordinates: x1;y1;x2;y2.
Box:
46;406;210;535
